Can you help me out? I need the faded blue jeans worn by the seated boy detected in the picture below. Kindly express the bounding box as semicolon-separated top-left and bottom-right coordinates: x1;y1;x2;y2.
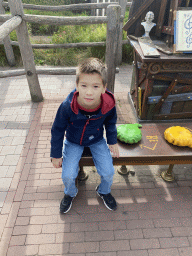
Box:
62;138;115;197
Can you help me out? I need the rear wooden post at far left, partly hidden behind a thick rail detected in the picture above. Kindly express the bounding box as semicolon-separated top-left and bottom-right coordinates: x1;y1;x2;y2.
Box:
0;0;16;67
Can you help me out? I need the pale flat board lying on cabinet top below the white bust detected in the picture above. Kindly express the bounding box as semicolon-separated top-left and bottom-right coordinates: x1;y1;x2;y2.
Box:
138;37;160;58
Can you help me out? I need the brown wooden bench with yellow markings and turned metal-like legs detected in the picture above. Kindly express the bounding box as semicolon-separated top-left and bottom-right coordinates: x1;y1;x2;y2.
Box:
79;122;192;181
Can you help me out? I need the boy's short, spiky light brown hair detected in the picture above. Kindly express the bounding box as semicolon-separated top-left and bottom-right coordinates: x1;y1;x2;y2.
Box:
76;58;107;86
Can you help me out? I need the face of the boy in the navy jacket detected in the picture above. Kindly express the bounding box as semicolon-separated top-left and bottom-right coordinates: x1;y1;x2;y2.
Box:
76;73;106;109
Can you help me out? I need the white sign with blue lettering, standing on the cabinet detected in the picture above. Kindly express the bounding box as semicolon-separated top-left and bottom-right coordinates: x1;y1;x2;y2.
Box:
174;10;192;53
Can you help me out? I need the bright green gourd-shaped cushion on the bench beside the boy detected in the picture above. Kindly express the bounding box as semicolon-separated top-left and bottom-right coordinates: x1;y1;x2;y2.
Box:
117;124;142;144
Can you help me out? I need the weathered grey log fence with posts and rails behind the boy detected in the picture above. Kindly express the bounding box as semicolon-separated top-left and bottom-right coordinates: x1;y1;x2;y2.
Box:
0;0;130;102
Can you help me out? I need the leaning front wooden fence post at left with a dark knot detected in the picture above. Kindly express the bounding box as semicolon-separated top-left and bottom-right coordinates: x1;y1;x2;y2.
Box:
8;0;43;102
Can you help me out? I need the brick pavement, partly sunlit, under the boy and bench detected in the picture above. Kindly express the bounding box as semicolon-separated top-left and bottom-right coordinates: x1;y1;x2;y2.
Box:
0;66;192;256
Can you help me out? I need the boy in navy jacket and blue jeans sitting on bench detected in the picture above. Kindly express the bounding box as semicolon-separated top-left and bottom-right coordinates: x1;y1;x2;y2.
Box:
51;58;119;213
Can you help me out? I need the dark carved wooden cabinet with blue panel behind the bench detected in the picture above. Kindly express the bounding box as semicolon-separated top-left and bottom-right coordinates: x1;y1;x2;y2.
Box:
130;40;192;121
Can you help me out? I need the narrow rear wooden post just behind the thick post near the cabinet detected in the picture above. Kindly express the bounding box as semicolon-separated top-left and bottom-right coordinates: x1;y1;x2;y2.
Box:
117;0;127;65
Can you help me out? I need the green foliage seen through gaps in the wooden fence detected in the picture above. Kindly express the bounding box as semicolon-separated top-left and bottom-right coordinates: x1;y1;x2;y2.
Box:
0;0;133;66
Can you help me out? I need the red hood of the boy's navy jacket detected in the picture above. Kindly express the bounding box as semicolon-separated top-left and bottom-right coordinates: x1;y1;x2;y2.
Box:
71;90;115;115
